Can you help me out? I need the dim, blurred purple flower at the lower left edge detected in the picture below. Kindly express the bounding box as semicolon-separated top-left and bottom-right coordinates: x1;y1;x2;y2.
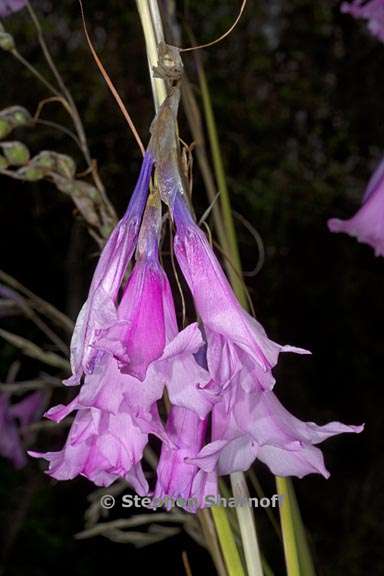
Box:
0;392;45;468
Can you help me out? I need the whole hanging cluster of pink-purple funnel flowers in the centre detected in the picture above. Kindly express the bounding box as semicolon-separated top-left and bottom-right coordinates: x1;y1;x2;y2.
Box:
31;124;362;506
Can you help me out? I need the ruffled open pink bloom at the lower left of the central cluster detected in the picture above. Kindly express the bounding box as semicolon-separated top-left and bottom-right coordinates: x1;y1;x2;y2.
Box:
29;372;162;495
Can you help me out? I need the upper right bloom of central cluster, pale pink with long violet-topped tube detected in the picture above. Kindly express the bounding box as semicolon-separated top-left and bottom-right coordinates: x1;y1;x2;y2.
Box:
174;195;307;389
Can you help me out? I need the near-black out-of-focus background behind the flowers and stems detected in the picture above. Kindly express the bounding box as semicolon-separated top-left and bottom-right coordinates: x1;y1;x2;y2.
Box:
0;0;384;576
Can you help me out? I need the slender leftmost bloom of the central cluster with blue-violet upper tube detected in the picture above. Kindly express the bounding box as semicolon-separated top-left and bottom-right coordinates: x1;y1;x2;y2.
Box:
65;153;153;385
